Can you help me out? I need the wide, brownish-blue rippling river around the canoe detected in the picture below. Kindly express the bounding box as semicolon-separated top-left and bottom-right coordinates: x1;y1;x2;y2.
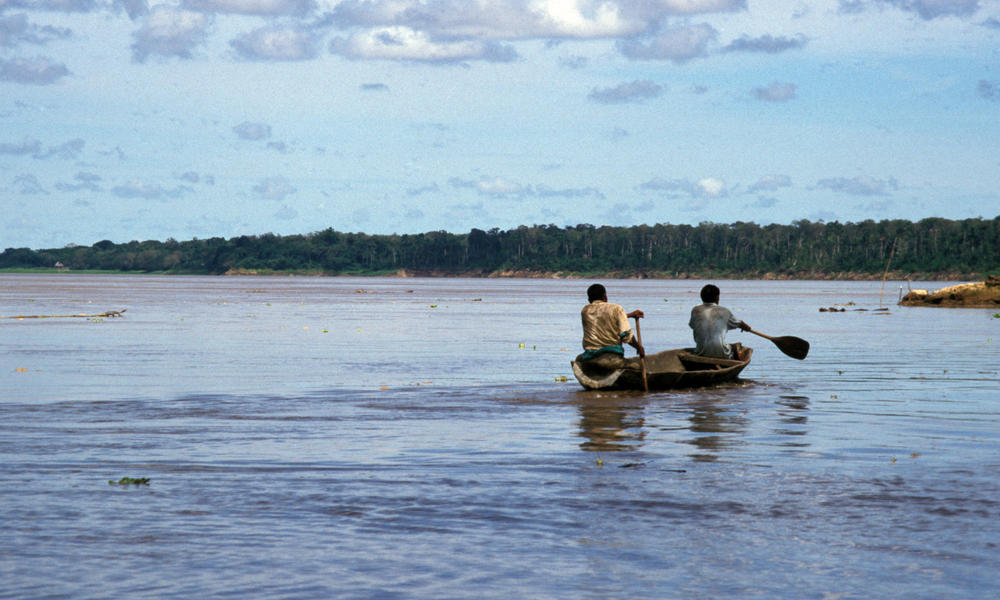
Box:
0;273;1000;600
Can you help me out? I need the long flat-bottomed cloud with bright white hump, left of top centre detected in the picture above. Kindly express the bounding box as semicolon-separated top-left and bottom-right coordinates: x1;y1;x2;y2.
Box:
330;27;519;63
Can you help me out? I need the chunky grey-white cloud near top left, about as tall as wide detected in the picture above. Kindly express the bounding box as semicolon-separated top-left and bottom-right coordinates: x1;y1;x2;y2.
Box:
132;5;211;62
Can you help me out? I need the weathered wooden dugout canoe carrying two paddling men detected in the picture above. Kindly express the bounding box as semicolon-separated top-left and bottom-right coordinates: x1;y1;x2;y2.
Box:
570;346;753;391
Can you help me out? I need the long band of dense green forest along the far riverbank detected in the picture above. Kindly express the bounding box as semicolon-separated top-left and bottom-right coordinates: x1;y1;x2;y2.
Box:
0;216;1000;279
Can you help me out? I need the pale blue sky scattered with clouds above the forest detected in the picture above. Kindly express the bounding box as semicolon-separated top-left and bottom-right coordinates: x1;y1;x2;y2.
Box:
0;0;1000;249
